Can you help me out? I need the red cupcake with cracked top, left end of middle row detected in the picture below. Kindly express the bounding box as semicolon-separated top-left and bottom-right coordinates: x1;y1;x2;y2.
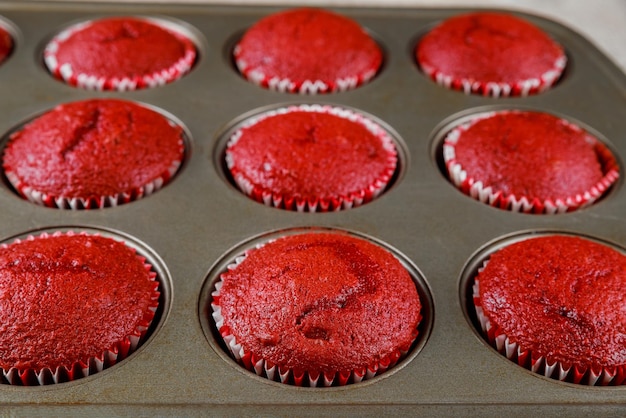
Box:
3;99;184;209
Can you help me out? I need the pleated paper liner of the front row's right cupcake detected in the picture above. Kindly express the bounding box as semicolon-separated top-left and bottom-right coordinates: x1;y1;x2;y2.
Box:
472;274;626;386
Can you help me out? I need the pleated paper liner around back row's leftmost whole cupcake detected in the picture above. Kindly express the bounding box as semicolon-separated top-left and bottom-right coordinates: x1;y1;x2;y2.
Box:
43;21;197;91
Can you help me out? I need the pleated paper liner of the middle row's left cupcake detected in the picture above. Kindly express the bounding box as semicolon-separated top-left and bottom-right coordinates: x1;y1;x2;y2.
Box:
5;156;184;210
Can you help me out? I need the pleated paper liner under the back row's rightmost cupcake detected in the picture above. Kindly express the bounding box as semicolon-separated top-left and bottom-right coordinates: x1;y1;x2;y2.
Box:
420;55;567;97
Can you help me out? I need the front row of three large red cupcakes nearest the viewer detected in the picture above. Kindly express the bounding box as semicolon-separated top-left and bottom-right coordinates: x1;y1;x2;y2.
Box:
0;228;626;387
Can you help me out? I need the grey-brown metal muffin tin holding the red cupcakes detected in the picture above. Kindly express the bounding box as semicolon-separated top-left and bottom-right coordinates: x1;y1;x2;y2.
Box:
0;1;626;416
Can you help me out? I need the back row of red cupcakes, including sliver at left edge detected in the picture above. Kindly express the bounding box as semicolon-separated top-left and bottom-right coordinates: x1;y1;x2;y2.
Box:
0;8;567;97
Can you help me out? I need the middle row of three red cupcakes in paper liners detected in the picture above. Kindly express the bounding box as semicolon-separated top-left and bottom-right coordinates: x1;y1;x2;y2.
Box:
2;99;619;214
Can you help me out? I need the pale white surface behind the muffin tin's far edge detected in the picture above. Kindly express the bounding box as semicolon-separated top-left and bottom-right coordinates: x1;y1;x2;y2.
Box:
30;0;626;72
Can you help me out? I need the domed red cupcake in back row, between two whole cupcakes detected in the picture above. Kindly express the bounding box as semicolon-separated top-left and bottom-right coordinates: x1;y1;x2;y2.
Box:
234;8;383;94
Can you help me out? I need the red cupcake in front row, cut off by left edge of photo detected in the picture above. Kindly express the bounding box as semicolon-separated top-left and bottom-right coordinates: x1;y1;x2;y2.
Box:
0;232;159;385
